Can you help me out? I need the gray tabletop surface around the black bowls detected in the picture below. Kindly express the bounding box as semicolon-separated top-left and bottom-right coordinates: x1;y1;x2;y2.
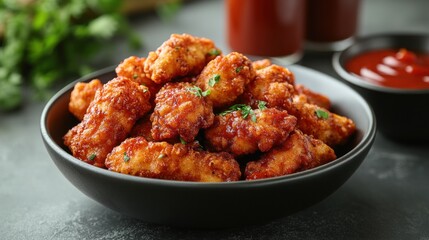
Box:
0;0;429;240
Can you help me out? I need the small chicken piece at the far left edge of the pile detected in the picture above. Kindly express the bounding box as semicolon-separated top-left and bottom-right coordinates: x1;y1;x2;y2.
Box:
69;79;103;121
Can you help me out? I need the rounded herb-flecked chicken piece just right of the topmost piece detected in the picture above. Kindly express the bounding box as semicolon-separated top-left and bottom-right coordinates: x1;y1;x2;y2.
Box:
195;52;255;108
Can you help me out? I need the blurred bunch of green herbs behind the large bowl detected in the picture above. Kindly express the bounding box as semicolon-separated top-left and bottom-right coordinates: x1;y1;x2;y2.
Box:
0;0;141;110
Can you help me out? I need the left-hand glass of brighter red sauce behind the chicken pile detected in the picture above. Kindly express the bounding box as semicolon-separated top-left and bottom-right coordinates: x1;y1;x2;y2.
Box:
226;0;306;62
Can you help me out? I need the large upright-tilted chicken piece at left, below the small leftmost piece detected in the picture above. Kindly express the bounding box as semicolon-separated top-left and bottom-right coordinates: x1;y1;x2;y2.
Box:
64;77;151;167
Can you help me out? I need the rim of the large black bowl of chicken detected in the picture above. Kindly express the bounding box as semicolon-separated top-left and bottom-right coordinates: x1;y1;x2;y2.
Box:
40;65;376;189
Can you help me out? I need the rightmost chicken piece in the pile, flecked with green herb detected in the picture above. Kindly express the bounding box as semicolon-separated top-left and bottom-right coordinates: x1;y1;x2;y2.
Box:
288;95;356;147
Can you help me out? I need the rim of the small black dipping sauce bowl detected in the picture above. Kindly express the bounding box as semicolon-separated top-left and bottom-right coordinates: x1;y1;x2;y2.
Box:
332;32;429;95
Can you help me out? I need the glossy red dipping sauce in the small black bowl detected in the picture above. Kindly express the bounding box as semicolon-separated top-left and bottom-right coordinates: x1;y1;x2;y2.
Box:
346;49;429;89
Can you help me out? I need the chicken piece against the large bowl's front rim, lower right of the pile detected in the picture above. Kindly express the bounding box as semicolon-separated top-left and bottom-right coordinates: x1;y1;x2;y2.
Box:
245;131;336;180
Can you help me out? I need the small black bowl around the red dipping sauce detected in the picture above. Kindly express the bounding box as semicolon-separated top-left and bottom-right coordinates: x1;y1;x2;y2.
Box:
332;34;429;143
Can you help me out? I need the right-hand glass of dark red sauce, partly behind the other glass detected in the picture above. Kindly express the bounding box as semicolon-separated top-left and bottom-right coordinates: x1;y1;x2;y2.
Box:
306;0;360;51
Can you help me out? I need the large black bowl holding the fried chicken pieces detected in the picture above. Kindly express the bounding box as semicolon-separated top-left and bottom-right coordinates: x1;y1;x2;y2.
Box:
41;66;376;228
